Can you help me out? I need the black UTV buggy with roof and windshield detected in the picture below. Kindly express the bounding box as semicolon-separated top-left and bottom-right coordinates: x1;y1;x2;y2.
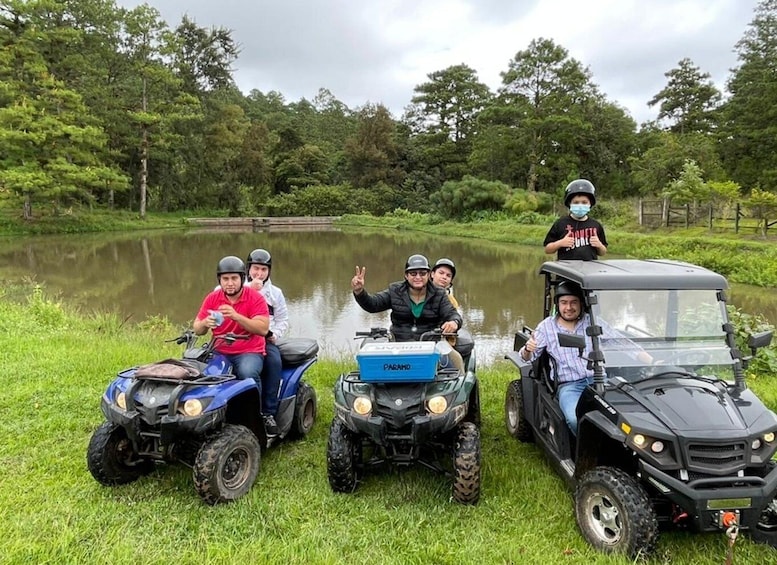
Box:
505;260;777;557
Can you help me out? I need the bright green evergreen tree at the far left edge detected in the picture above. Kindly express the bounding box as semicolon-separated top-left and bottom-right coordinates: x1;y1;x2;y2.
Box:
0;2;128;220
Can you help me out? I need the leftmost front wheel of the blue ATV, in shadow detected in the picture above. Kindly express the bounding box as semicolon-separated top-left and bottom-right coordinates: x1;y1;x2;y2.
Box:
86;422;154;486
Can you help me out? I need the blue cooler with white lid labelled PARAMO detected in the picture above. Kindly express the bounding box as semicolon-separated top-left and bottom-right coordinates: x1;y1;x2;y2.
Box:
356;341;440;383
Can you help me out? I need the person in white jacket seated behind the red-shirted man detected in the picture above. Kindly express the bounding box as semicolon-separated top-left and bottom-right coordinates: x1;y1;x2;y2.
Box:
246;249;289;435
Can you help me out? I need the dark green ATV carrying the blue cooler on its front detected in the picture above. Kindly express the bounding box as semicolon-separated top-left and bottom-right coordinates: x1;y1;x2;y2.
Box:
327;328;480;504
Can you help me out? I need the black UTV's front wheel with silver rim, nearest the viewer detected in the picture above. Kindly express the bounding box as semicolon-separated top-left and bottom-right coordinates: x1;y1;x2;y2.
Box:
575;467;658;559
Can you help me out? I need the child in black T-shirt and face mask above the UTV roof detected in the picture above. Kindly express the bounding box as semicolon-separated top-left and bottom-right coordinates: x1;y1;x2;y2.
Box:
543;179;607;261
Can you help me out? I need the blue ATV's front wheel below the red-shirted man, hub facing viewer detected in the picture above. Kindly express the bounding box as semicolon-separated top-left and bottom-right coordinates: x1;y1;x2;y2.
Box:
193;424;261;505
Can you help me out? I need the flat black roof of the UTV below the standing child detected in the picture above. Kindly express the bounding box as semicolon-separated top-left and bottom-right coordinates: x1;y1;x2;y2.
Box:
540;259;728;290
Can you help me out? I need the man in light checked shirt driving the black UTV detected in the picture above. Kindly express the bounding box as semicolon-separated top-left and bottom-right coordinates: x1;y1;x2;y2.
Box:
518;281;653;435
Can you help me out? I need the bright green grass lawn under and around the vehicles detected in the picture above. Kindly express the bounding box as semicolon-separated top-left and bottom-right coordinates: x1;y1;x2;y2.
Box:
0;297;777;565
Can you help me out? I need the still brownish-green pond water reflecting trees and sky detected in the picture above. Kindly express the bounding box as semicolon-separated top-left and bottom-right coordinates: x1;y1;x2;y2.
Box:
0;230;777;364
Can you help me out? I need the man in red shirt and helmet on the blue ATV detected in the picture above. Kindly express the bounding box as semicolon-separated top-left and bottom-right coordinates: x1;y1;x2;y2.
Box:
192;255;270;391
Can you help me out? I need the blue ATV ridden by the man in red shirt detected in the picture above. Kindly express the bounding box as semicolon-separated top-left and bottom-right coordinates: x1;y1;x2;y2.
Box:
87;330;318;505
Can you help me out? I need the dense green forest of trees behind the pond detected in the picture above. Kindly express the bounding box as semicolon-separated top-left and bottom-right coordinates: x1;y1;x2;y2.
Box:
0;0;777;220
